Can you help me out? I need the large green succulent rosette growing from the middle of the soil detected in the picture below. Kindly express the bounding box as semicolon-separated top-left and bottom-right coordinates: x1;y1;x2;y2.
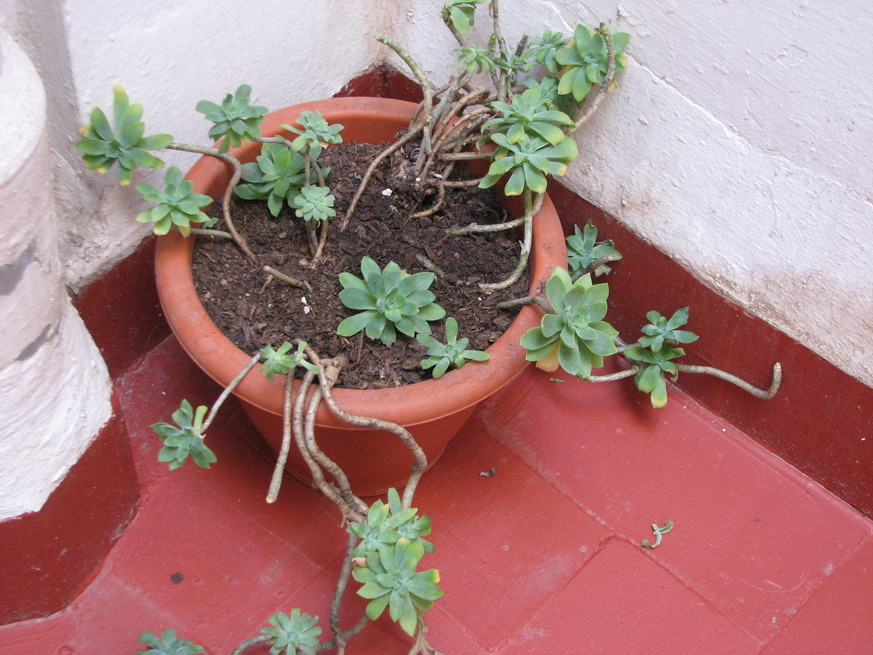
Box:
336;257;446;345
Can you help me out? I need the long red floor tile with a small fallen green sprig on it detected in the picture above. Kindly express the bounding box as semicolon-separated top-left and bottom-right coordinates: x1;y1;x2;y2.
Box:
483;366;873;641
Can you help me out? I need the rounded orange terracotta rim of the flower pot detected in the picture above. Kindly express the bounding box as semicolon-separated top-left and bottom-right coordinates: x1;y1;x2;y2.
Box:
155;98;566;428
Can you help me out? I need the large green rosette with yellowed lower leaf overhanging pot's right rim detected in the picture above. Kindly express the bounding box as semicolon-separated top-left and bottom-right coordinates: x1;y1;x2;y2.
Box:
521;268;618;378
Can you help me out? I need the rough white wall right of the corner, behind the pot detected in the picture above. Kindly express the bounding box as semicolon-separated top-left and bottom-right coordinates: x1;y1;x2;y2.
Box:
394;0;873;385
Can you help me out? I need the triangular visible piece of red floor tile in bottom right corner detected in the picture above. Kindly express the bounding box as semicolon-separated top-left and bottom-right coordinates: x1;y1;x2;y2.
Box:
763;537;873;655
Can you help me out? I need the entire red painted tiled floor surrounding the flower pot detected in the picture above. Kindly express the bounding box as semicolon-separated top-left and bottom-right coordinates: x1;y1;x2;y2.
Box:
0;339;873;655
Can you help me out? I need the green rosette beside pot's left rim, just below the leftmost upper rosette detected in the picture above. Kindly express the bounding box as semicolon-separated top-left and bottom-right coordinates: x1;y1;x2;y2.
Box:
135;166;213;236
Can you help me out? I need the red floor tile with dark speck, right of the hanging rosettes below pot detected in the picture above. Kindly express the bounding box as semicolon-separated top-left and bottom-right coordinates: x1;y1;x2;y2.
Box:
416;426;610;650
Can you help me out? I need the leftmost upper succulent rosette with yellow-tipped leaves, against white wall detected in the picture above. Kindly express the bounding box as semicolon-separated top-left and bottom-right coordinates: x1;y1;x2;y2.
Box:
76;85;173;185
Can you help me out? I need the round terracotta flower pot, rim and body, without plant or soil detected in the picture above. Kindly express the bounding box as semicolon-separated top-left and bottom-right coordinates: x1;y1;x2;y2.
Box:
155;98;567;496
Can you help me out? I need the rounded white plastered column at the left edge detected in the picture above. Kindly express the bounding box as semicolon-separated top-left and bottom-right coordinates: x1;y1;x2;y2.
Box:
0;26;112;520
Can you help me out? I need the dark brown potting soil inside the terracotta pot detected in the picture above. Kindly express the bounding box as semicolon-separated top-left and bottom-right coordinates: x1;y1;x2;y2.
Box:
193;138;529;389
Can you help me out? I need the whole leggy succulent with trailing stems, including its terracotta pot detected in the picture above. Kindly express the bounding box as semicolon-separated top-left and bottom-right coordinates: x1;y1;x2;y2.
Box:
78;0;778;655
